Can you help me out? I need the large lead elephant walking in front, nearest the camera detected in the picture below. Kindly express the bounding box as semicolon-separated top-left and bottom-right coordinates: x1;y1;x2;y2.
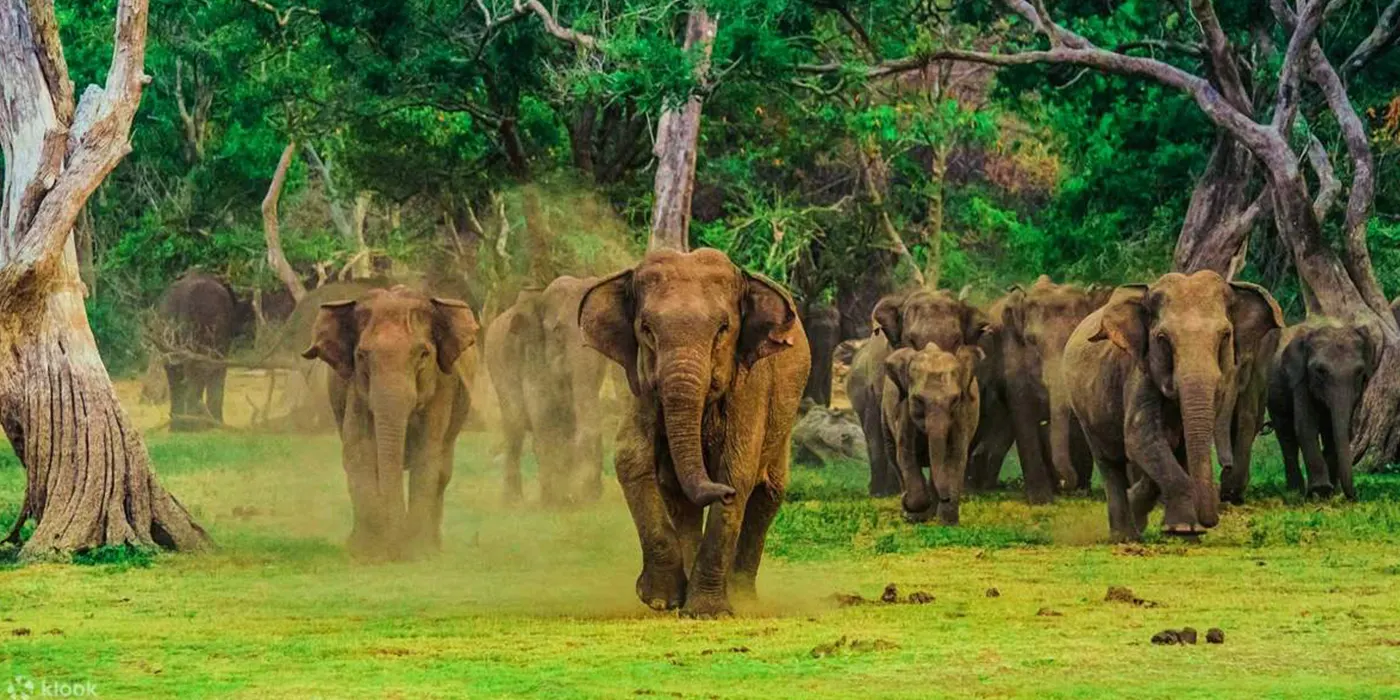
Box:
578;249;811;617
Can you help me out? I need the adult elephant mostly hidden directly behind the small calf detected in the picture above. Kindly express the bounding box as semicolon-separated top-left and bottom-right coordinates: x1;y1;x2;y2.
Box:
846;290;988;497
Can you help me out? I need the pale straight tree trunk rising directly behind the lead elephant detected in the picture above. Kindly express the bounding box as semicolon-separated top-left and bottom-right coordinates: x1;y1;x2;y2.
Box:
650;7;720;251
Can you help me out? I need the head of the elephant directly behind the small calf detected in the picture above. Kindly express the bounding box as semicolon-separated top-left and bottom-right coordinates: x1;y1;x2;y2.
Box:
871;290;988;350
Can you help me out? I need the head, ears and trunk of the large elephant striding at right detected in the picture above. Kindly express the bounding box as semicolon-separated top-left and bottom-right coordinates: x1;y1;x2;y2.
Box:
1091;270;1282;528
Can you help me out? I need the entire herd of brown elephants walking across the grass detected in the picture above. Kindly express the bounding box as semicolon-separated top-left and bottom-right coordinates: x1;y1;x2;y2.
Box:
158;249;1379;617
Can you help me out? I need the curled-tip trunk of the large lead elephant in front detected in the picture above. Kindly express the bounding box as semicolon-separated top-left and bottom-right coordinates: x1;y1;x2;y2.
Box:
659;353;734;507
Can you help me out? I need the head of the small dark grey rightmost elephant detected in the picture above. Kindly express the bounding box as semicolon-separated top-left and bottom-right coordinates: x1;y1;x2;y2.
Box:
1280;322;1380;478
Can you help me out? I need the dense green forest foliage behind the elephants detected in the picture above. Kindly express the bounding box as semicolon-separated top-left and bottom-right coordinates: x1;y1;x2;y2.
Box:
46;0;1400;374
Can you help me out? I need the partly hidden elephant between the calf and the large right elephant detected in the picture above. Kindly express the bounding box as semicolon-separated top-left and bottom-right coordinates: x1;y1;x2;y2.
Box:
998;274;1113;503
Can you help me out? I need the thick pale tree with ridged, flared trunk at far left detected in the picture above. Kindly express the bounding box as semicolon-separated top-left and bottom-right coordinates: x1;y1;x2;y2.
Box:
0;0;209;559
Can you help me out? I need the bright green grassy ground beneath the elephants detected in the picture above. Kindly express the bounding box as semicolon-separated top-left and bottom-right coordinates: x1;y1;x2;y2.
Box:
0;375;1400;699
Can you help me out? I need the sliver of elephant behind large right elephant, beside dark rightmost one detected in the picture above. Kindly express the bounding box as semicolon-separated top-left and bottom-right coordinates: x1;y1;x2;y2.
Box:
1217;281;1282;505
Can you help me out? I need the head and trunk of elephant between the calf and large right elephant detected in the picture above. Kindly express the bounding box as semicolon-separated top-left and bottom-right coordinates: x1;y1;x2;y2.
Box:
1000;274;1113;489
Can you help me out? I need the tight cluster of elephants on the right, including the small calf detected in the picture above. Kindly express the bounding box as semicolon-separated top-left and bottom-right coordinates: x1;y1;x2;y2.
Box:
847;272;1379;540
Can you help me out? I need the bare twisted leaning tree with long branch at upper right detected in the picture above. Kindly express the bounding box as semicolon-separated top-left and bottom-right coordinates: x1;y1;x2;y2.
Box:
799;0;1400;459
